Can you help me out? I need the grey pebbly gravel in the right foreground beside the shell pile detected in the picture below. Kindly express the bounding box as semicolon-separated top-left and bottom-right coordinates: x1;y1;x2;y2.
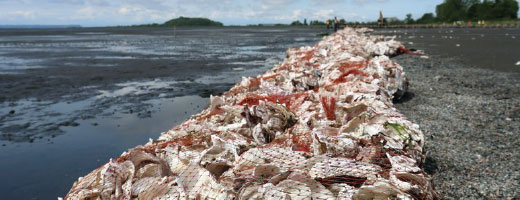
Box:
395;56;520;199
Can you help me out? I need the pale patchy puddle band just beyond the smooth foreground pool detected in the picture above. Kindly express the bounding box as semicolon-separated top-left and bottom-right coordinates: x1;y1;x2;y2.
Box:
0;69;254;142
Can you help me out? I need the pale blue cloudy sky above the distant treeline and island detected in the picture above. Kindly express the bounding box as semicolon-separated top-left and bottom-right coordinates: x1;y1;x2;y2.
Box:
0;0;512;26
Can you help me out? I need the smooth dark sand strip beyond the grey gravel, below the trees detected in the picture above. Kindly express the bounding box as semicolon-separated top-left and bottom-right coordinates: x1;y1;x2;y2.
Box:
376;28;520;72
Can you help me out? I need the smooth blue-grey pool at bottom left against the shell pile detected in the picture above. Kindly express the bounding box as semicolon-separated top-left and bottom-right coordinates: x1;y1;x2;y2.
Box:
0;96;209;199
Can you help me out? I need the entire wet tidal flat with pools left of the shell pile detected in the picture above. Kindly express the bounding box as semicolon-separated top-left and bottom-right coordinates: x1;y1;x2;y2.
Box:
0;28;321;199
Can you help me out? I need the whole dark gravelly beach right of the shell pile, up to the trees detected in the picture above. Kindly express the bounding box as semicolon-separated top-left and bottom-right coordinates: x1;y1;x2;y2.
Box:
380;29;520;199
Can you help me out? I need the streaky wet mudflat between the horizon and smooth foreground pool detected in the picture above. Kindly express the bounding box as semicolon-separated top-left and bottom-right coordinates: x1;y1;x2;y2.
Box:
0;28;320;142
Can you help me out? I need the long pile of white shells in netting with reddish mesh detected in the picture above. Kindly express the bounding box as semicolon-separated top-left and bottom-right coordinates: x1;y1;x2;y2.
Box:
66;28;438;200
